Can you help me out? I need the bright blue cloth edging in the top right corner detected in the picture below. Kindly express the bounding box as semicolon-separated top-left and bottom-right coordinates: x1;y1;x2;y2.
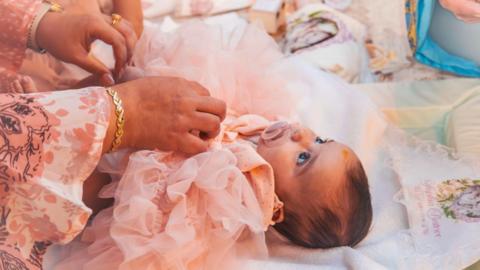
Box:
407;0;480;77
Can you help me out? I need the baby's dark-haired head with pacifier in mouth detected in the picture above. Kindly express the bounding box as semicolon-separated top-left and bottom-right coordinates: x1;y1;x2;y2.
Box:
257;122;372;248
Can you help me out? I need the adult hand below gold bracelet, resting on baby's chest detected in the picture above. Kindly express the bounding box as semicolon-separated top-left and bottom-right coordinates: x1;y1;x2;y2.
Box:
105;77;226;154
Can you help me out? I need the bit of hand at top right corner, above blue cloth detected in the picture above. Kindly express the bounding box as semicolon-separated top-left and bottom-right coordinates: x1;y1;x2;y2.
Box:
439;0;480;23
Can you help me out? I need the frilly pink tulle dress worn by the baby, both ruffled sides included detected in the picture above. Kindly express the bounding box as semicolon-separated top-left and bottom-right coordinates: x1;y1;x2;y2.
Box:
55;23;293;270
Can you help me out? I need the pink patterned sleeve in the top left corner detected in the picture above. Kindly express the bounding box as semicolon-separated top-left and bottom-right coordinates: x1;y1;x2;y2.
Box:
0;0;42;88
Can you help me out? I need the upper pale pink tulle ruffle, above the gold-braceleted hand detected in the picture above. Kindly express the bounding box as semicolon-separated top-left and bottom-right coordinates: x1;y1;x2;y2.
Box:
134;22;296;120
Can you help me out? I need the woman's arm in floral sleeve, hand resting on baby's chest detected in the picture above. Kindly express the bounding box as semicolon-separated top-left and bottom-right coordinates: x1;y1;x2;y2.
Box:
0;77;226;269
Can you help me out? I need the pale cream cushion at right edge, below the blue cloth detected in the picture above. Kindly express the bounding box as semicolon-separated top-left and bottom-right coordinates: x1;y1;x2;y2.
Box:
355;79;480;155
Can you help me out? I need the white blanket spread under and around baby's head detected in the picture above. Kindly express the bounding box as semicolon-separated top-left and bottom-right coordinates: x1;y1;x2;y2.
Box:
244;60;480;270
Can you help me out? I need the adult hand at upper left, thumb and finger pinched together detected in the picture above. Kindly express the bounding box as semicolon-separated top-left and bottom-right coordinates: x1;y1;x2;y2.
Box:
36;7;137;85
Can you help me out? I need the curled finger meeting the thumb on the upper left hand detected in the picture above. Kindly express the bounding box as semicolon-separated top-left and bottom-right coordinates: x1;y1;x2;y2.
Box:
92;21;128;77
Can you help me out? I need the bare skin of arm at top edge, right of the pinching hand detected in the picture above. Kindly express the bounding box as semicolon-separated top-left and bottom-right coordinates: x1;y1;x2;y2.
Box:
113;0;143;37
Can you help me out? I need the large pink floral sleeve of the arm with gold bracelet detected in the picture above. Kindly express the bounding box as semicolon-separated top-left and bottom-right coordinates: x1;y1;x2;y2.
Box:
0;88;111;269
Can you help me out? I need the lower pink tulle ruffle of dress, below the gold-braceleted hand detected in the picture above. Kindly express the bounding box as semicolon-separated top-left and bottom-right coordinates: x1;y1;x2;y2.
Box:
56;146;267;270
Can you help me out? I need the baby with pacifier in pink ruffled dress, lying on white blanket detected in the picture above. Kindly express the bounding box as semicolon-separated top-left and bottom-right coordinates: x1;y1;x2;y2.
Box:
60;115;372;270
